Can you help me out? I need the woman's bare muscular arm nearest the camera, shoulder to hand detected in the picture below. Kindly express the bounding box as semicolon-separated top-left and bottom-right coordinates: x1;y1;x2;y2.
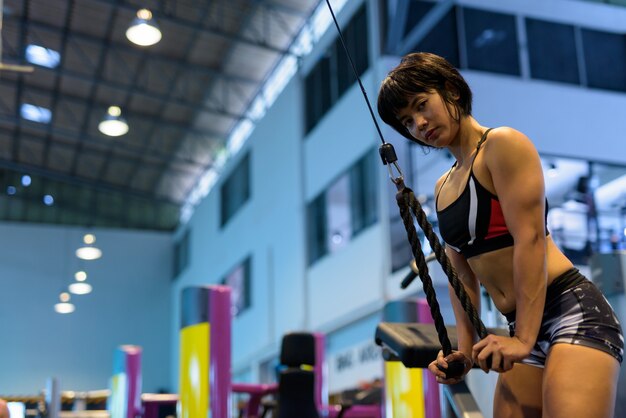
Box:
475;128;547;370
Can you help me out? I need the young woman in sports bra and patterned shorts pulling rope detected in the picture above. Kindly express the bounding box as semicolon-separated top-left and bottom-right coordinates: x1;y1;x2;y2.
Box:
378;53;624;418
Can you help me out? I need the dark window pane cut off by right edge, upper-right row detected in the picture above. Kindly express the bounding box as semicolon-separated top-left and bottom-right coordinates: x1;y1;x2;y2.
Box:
581;29;626;91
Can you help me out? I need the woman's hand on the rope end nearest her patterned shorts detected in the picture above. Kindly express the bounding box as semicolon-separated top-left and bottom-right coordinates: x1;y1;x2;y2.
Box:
472;334;532;373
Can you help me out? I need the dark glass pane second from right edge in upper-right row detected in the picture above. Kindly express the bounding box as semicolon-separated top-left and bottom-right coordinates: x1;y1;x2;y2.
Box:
526;18;580;84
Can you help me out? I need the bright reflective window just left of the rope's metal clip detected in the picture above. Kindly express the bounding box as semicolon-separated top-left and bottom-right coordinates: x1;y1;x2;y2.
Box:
307;152;378;264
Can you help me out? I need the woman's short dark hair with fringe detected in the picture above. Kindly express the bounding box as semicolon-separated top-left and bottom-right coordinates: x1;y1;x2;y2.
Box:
378;52;472;146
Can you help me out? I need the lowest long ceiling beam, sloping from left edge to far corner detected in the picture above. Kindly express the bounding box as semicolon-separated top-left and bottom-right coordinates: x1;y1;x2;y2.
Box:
0;158;182;207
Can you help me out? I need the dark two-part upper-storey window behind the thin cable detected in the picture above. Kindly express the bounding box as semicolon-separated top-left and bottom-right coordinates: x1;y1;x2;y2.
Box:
304;7;369;133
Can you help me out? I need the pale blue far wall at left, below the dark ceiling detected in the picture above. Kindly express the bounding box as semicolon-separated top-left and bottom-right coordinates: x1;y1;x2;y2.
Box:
0;223;172;395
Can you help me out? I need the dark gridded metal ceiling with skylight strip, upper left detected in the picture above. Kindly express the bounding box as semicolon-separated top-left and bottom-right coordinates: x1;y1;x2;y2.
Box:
0;0;319;230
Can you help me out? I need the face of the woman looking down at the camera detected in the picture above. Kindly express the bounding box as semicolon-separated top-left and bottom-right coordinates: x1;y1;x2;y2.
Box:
397;91;459;148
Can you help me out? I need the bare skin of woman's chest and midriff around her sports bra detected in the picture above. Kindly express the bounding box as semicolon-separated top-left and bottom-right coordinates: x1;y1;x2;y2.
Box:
437;131;572;313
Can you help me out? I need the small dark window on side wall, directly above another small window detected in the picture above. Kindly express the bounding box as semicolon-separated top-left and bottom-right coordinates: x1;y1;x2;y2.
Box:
221;154;250;226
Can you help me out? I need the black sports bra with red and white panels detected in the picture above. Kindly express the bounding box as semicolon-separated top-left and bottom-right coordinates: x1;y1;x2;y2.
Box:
435;128;548;258
